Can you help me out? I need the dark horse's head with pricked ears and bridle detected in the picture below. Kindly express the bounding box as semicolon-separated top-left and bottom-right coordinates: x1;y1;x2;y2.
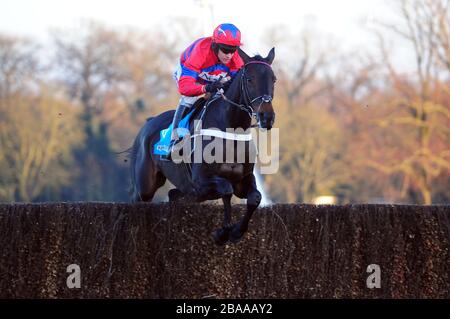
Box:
239;48;276;130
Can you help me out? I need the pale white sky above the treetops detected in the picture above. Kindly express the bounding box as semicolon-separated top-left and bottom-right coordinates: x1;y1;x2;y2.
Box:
0;0;385;51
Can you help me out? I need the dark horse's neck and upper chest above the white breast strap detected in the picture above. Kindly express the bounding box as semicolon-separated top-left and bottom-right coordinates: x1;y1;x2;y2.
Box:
205;74;251;131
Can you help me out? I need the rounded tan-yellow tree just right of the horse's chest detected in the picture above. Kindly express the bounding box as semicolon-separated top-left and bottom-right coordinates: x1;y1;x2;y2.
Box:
266;105;347;203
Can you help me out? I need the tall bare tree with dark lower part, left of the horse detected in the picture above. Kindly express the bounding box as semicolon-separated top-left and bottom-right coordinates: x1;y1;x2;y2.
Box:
54;21;137;200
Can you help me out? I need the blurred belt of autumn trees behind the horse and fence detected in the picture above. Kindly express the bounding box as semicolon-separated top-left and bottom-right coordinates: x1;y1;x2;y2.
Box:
0;11;450;203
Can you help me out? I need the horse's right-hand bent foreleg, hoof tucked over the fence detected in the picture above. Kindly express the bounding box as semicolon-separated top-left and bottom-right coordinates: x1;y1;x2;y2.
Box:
230;174;261;243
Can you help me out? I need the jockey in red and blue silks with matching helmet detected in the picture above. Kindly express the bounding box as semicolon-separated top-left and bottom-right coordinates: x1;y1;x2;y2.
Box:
161;23;244;159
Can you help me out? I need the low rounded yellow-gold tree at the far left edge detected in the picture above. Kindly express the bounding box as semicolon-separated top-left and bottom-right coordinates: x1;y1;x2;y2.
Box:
0;87;83;201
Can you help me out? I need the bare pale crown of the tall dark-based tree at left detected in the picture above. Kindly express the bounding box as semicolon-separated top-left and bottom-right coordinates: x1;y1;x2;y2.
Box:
53;21;128;116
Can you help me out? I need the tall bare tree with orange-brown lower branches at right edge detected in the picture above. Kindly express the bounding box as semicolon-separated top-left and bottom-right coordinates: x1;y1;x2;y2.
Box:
368;0;450;204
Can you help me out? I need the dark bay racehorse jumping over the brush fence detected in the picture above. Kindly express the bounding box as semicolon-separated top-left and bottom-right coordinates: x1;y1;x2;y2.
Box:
130;48;276;245
